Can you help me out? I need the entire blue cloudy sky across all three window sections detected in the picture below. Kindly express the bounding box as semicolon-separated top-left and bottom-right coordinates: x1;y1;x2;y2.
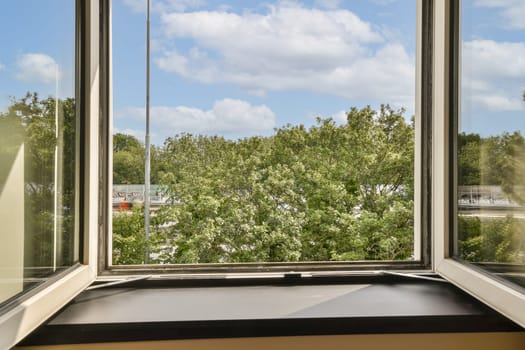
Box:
0;0;525;144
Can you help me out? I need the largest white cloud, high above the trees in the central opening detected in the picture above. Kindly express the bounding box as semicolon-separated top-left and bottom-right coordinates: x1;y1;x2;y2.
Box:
155;2;415;109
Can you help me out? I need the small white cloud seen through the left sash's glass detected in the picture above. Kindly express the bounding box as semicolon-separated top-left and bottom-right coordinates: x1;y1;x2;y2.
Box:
15;53;62;84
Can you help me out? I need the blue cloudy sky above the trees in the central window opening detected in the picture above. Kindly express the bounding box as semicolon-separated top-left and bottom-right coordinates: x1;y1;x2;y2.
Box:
113;0;415;143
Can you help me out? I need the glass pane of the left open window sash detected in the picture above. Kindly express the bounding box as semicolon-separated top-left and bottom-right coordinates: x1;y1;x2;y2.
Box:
0;0;78;303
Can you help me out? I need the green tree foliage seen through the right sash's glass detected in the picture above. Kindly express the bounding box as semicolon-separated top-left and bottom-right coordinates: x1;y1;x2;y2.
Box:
458;132;525;264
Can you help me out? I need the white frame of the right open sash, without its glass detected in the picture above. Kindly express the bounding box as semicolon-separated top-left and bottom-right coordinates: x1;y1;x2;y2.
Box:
432;0;525;327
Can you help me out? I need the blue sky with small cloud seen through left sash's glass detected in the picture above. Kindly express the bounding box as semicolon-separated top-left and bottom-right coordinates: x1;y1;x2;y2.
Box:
0;0;75;111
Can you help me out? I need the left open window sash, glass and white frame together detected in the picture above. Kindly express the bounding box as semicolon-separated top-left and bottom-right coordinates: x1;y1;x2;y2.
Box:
0;0;96;348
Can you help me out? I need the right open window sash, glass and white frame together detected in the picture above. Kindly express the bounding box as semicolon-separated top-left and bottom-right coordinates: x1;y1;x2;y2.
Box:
434;1;525;325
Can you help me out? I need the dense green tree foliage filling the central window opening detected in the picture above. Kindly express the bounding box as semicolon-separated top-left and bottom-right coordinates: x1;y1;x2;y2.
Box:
114;106;414;263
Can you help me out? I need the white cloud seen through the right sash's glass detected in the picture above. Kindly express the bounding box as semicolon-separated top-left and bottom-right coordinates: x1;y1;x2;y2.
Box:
462;40;525;111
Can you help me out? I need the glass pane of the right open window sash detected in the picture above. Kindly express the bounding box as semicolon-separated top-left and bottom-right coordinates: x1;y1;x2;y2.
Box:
456;1;525;286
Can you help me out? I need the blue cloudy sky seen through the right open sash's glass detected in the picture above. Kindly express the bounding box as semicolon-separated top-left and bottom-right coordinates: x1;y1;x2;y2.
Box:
460;0;525;135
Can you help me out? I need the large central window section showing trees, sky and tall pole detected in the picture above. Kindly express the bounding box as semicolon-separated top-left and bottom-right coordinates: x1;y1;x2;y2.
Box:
112;0;416;264
